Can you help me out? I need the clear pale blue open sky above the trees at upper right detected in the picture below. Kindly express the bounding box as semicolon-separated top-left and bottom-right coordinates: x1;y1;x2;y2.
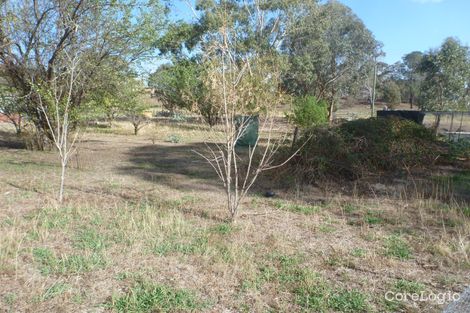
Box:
340;0;470;64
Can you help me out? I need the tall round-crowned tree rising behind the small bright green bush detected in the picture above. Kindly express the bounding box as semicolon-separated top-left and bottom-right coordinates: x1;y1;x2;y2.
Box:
283;1;380;120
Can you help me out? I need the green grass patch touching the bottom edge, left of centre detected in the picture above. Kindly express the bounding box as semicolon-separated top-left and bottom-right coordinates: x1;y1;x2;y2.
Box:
110;282;206;312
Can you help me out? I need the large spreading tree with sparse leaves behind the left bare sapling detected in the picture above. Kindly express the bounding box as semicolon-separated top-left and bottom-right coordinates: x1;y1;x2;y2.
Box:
0;0;166;149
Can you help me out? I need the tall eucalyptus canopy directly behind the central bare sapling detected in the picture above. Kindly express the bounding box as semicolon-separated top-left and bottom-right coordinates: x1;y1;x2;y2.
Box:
149;0;302;126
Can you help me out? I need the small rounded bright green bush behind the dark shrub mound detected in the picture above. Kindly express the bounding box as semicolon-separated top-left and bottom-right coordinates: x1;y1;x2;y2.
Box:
289;96;328;128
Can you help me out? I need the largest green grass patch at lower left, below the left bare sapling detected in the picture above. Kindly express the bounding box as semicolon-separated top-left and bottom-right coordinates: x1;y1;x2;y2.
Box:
33;248;106;275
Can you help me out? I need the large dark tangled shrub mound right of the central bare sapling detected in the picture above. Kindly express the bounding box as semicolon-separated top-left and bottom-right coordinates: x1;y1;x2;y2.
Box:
294;118;441;181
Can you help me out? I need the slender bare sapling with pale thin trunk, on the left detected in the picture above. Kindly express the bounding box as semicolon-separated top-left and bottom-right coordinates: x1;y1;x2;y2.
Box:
32;54;80;202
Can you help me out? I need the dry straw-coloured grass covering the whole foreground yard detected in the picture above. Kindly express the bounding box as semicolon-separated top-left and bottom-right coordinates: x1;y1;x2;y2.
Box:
0;123;470;312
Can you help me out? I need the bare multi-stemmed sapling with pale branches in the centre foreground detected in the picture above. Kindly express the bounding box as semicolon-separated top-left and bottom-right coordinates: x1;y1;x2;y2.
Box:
196;14;298;220
